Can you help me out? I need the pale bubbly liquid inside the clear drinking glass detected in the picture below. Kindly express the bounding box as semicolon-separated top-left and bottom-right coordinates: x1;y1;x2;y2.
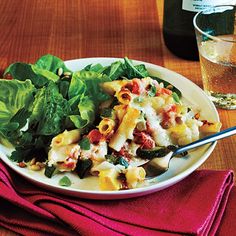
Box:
199;35;236;109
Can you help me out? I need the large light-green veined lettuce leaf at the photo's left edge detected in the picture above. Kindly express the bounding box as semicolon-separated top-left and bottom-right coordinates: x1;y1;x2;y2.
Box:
0;79;35;143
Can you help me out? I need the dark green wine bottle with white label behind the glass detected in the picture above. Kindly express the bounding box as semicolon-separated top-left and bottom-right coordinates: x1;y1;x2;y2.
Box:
163;0;234;60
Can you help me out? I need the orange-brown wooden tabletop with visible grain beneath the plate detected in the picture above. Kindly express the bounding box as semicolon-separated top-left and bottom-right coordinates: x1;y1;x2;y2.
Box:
0;0;236;235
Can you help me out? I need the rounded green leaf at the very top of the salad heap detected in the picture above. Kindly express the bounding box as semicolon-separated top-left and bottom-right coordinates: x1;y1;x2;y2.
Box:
35;54;71;74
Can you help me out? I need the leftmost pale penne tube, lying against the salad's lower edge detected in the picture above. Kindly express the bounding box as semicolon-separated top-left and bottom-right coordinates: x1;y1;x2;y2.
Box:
51;129;80;147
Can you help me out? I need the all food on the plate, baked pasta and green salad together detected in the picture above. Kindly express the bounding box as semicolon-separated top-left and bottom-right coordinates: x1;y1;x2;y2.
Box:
0;55;221;191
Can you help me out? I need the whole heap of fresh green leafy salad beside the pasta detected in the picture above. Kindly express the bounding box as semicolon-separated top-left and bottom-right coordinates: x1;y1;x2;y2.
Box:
0;55;181;162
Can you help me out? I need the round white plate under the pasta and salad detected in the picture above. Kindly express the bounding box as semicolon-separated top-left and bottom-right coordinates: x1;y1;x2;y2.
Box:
0;58;219;199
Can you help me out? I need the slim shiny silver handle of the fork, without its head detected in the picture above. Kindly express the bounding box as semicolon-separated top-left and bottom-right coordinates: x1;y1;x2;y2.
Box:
173;126;236;156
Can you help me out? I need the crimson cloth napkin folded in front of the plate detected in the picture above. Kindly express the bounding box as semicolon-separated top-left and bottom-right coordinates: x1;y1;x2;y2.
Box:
0;162;236;236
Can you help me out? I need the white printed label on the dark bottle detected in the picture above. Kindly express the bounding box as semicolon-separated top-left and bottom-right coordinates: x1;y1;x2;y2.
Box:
182;0;236;12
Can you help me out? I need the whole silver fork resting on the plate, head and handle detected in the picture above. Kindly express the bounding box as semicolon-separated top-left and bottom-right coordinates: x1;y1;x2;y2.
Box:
141;126;236;178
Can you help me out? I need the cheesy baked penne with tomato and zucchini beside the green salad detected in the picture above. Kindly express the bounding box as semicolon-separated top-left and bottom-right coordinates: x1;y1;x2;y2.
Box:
48;77;219;190
